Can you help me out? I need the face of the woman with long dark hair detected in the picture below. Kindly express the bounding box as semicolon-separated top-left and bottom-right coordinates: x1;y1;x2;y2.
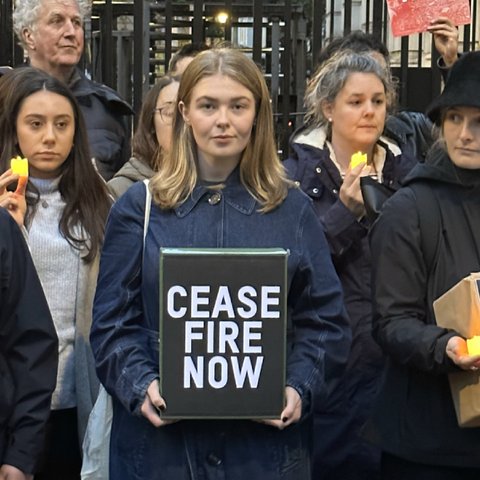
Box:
16;90;75;178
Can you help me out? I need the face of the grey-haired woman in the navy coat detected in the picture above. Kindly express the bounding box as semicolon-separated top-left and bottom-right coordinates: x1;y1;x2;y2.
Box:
323;72;387;152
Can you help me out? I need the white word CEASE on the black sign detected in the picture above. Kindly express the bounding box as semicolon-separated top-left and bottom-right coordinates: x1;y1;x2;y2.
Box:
167;285;280;319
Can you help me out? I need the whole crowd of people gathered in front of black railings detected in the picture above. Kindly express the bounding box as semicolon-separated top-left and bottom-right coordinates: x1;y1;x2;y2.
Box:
0;0;480;480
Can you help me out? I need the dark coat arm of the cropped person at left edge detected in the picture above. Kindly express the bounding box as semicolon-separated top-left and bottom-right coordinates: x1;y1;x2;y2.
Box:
0;208;58;473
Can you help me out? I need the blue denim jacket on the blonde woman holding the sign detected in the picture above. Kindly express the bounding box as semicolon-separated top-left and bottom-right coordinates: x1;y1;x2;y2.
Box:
91;171;350;480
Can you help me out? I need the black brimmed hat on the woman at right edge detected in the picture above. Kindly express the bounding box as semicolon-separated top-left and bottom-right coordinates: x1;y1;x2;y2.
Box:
427;51;480;125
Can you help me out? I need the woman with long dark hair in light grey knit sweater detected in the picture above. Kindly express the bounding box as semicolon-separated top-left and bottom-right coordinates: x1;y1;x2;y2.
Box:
0;67;110;480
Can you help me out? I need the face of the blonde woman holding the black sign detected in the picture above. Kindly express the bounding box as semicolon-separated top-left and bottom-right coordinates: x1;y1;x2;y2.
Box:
180;74;255;181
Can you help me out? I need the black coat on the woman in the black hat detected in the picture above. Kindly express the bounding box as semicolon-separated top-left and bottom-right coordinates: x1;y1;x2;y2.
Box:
370;150;480;468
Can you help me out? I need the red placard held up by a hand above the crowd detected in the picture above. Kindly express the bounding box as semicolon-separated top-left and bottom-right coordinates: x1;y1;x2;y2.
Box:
387;0;471;37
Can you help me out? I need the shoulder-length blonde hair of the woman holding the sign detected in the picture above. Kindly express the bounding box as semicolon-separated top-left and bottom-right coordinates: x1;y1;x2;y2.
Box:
150;48;290;212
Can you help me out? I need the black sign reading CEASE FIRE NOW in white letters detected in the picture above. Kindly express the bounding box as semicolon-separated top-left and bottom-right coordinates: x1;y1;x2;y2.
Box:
160;248;288;418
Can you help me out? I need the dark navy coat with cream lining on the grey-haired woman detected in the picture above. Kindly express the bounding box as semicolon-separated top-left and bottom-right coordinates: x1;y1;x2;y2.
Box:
285;119;431;479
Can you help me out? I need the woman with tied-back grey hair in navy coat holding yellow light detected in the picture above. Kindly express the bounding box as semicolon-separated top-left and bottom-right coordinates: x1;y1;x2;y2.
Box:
285;51;416;480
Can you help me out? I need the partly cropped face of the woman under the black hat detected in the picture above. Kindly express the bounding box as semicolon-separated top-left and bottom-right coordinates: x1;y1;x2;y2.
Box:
443;107;480;170
